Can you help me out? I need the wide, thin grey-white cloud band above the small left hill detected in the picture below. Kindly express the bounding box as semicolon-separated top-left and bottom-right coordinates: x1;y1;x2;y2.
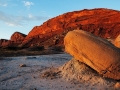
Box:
0;11;50;26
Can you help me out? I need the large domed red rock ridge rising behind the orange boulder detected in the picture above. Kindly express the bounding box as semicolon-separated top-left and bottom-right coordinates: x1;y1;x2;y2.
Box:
23;8;120;45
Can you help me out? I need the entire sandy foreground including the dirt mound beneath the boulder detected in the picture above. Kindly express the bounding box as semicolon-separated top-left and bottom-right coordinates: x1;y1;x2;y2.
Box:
0;54;120;90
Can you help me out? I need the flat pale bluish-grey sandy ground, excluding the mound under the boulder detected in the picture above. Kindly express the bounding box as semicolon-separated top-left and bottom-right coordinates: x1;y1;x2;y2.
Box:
0;54;119;90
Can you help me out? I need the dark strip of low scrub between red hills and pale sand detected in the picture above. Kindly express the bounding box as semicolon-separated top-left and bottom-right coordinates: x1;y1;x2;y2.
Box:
0;46;62;57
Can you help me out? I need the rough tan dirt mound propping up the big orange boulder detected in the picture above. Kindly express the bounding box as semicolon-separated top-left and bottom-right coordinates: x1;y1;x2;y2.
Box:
60;58;117;90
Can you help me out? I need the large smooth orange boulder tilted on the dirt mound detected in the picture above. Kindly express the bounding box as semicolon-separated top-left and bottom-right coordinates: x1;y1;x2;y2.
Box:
64;30;120;80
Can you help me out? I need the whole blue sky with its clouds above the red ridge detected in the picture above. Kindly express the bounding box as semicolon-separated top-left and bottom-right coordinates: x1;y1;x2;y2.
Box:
0;0;120;39
